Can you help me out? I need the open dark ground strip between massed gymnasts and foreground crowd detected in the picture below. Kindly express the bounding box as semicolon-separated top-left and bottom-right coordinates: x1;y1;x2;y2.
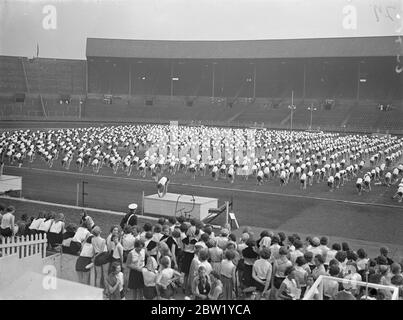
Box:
0;123;403;244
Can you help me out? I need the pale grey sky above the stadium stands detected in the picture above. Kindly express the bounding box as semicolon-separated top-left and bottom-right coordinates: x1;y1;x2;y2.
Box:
0;0;403;59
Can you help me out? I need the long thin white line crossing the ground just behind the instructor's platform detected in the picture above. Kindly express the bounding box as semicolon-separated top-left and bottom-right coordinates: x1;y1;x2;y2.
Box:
5;166;403;209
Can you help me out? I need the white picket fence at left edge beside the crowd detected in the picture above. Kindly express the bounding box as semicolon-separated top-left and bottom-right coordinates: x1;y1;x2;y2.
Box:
0;234;48;259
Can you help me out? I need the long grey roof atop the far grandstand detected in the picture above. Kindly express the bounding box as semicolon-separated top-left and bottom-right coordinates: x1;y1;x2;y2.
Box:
86;36;402;59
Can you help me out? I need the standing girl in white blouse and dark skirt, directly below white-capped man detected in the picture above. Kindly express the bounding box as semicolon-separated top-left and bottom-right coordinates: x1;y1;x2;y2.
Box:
126;240;146;300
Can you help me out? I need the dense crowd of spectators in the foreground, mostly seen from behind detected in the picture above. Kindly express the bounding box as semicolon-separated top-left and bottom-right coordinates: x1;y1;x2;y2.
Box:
0;202;403;300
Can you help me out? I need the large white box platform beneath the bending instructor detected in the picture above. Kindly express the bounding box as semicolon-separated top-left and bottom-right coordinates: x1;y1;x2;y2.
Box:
143;193;218;220
